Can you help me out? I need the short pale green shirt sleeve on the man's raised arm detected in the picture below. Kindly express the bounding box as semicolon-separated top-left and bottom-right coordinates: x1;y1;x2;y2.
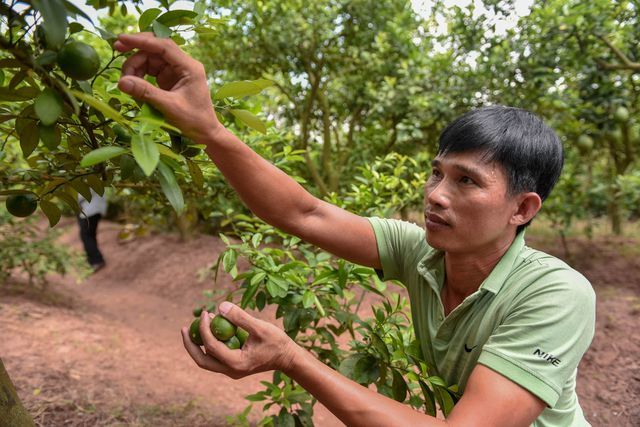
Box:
368;217;426;282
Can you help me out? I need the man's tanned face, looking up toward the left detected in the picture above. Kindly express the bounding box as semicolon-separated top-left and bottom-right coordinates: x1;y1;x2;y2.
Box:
424;151;518;254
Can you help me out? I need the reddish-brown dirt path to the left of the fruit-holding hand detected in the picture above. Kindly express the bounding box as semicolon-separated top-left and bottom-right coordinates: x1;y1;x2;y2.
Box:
0;223;341;426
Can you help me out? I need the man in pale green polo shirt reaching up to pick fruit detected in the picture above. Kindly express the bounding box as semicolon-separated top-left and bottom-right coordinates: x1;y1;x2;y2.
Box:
115;34;595;427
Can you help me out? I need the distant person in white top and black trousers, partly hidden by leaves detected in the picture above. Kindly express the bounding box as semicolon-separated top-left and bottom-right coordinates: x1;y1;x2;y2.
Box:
78;190;107;272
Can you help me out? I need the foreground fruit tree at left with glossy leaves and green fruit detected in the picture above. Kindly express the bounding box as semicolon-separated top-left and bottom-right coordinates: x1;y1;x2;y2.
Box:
0;0;269;425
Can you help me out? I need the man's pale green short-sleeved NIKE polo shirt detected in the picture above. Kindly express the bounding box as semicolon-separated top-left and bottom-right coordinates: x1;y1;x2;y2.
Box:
369;218;595;426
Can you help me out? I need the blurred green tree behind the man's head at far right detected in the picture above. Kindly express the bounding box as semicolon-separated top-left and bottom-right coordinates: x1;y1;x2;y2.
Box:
434;0;640;234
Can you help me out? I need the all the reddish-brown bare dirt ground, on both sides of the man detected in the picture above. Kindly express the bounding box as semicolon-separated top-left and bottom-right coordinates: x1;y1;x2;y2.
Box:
0;220;640;427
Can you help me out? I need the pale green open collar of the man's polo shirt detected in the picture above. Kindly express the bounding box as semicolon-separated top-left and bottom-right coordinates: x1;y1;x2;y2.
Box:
418;230;525;294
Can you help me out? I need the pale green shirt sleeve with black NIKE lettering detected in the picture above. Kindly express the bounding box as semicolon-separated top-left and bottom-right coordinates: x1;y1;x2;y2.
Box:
478;268;595;408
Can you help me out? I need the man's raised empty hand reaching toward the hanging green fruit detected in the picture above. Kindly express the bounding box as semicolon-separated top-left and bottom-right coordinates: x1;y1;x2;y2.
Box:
114;33;222;142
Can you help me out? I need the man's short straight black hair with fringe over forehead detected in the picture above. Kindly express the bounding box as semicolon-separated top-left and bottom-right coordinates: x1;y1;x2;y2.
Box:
438;105;564;231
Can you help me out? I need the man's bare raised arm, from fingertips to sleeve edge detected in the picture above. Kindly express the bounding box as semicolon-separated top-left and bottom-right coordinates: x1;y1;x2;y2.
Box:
114;33;380;268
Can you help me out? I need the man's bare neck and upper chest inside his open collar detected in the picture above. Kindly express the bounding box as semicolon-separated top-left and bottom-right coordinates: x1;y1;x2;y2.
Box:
442;237;513;314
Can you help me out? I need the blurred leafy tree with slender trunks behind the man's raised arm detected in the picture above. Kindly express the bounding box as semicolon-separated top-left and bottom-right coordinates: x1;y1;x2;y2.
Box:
196;0;448;196
